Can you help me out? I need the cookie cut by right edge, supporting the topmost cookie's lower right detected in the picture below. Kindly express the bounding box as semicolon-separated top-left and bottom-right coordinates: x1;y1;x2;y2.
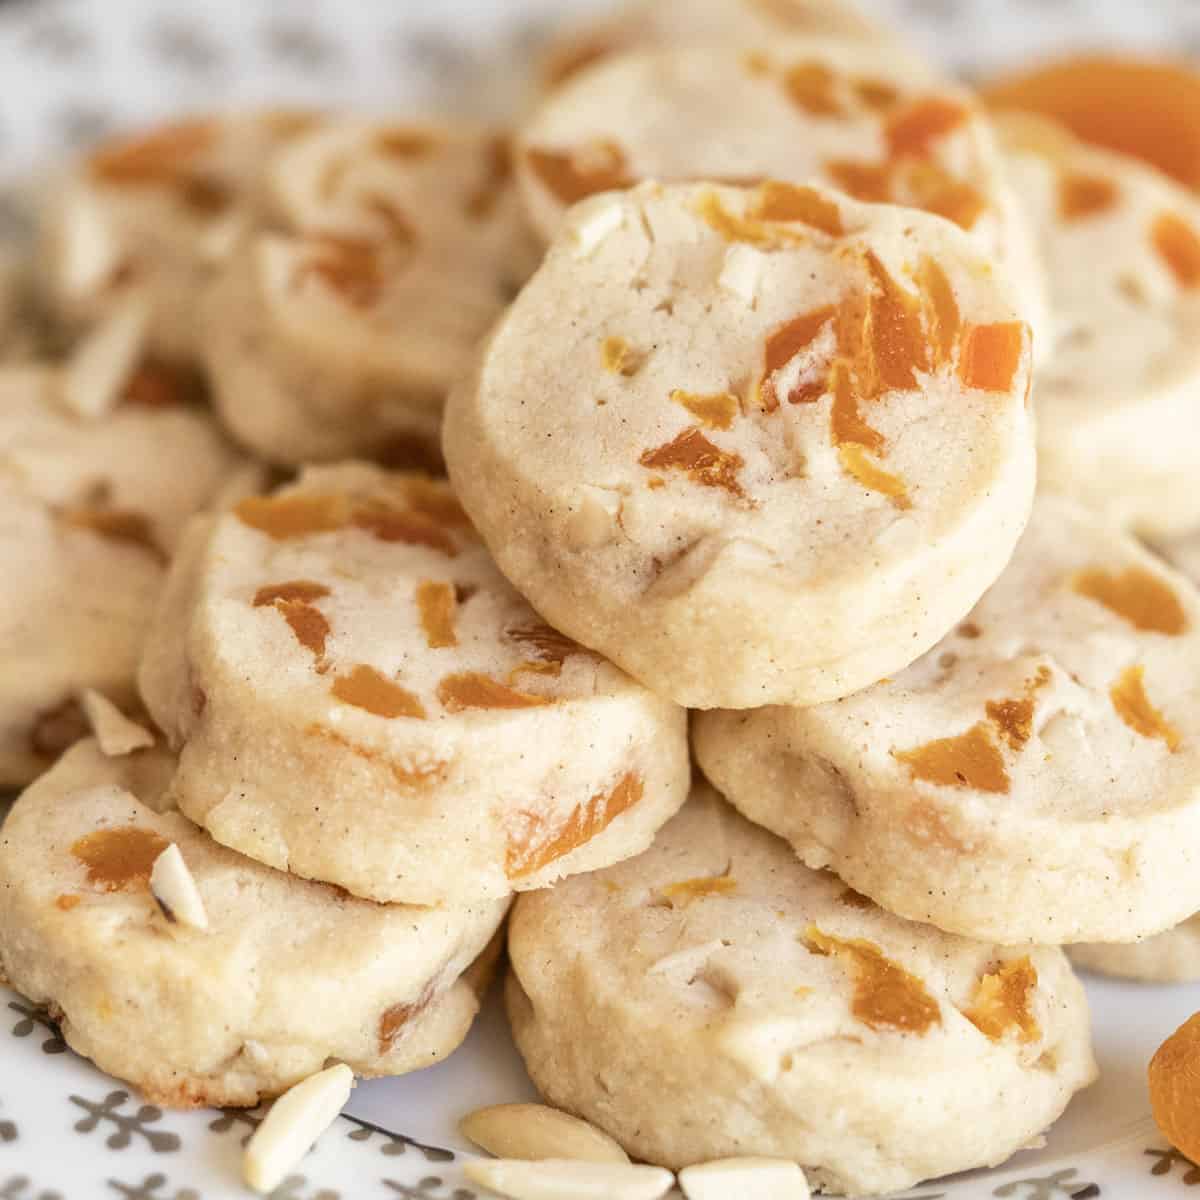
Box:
694;496;1200;944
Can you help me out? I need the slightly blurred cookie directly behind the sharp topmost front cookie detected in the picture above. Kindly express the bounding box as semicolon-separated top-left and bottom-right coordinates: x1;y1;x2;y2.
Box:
516;36;1046;346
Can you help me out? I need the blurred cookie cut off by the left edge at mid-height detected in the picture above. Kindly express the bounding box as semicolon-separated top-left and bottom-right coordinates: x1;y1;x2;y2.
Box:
0;367;245;786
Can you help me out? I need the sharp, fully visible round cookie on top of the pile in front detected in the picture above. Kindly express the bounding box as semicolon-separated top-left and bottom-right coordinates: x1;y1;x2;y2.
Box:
444;182;1034;708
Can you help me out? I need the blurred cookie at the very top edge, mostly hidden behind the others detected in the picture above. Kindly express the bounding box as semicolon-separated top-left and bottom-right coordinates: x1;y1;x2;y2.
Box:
542;0;895;86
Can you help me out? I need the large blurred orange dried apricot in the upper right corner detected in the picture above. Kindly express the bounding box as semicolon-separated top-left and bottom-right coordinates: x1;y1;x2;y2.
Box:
984;54;1200;187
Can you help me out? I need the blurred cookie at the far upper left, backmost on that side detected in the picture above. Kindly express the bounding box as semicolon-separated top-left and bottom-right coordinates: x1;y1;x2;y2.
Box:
40;110;319;362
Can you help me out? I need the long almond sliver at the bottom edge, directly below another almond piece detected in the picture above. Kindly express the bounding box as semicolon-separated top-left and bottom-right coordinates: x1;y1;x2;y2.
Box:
462;1158;674;1200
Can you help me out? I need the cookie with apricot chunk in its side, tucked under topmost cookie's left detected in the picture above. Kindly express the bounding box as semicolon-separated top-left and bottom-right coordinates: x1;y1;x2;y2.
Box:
139;464;690;904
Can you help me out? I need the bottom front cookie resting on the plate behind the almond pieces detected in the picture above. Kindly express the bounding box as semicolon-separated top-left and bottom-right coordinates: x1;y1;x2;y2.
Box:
508;785;1096;1195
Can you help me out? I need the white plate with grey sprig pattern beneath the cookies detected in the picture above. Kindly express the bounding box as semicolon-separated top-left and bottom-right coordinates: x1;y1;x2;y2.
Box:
0;0;1200;1200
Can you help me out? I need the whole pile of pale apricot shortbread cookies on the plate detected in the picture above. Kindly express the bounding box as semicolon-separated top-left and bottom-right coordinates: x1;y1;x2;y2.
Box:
0;0;1200;1193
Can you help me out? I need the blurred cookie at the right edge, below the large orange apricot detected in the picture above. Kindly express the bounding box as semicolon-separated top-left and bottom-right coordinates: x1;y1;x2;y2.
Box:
1000;116;1200;536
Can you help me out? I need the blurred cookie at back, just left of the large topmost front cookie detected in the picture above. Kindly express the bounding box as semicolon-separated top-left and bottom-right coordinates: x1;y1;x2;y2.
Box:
203;121;536;466
